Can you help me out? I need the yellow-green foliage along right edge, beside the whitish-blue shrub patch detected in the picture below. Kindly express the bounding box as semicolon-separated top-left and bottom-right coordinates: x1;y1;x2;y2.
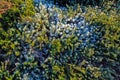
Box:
85;3;120;58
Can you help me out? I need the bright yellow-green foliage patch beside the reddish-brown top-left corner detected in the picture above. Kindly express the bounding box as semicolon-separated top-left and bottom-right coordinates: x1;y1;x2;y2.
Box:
4;0;35;17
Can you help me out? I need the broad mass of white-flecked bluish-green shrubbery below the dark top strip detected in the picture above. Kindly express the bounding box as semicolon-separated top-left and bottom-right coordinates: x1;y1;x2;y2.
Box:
0;0;120;80
